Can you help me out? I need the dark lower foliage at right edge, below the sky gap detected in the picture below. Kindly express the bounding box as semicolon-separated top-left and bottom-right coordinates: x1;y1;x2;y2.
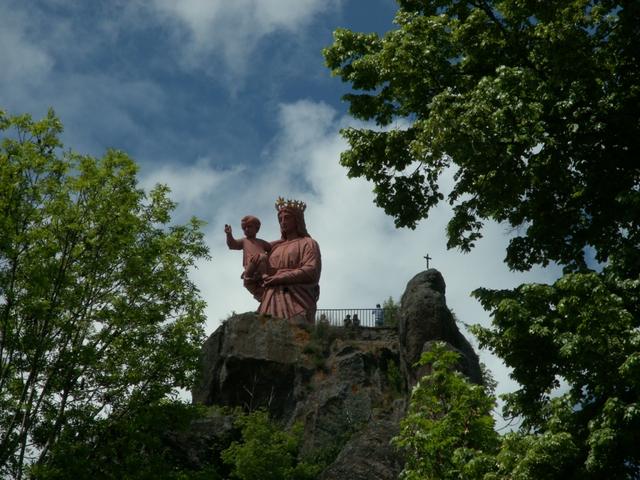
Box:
473;266;640;478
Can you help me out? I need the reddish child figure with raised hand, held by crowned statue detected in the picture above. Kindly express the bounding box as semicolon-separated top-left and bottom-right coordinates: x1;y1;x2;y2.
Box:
224;215;272;301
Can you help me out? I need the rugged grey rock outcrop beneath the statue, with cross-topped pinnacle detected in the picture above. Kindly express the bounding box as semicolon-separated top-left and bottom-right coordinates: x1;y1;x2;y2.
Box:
182;269;481;480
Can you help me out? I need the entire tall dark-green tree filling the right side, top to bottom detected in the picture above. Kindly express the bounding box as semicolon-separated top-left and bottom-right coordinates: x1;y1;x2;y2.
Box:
324;0;640;478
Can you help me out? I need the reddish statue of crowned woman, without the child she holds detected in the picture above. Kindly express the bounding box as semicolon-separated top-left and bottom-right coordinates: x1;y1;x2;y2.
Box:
250;197;322;323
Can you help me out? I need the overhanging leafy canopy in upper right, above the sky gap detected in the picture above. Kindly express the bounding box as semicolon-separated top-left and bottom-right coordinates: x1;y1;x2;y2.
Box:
324;0;640;270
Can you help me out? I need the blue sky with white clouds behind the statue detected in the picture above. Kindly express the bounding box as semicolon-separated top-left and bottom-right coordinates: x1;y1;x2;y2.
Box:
0;0;559;420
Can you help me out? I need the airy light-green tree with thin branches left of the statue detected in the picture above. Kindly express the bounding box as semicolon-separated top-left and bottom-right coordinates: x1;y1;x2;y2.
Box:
0;112;207;479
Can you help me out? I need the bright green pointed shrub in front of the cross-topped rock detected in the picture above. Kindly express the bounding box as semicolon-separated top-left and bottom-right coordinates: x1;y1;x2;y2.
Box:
393;343;499;480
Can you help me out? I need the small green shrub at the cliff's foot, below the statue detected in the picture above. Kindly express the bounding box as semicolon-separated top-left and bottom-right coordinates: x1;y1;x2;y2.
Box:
222;410;324;480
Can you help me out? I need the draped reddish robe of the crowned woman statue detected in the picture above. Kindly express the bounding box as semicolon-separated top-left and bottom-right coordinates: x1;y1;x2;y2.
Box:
258;237;322;323
